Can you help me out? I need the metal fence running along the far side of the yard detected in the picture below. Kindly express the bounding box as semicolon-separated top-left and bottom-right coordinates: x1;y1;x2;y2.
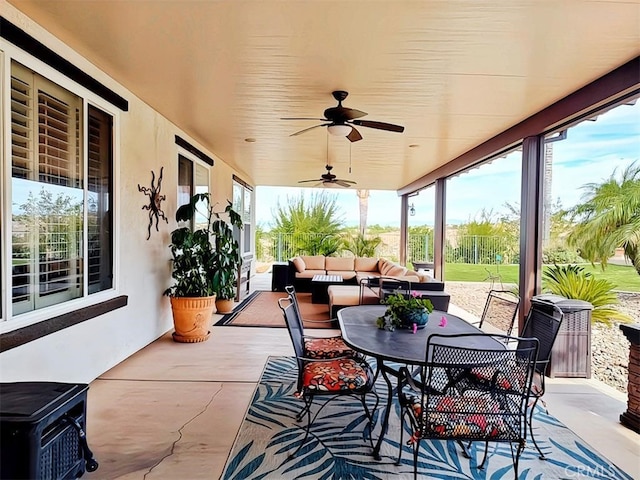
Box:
256;232;518;265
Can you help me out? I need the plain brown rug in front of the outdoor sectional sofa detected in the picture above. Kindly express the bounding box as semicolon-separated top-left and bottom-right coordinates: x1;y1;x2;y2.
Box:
216;292;336;328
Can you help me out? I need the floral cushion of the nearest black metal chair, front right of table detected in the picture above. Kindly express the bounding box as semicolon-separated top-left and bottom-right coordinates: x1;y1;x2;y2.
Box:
405;395;519;440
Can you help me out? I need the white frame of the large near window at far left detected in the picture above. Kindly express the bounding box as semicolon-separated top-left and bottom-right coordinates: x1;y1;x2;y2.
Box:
0;43;121;334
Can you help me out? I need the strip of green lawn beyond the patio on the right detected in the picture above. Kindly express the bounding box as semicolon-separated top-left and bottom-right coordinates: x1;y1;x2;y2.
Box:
445;263;640;292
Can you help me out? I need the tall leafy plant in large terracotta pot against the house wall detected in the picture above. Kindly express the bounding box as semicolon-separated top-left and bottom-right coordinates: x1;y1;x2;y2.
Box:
164;193;242;343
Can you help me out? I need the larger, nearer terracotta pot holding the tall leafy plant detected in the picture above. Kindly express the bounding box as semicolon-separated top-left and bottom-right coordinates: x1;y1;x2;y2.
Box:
171;295;216;343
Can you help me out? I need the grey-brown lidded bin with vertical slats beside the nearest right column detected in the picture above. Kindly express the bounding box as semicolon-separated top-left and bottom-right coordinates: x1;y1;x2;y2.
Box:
531;293;593;378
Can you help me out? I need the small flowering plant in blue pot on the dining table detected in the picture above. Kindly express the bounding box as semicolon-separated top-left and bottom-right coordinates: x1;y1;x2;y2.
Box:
376;290;433;331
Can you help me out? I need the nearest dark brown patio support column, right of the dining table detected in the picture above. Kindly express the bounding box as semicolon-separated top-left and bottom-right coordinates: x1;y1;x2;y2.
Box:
518;136;544;330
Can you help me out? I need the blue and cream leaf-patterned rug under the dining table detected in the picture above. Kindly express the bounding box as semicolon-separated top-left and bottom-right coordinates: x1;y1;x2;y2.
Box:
221;357;631;480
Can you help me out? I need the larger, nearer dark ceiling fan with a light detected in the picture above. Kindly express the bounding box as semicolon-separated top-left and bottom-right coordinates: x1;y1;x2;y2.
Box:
281;90;404;142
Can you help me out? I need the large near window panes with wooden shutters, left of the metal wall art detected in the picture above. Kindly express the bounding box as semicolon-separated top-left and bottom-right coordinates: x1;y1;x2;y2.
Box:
10;62;113;315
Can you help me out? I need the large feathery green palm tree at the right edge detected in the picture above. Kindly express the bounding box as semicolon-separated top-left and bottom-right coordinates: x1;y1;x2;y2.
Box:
568;161;640;275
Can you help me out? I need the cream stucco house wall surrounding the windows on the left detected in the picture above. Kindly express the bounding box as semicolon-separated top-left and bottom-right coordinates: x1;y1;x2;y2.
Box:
0;0;254;383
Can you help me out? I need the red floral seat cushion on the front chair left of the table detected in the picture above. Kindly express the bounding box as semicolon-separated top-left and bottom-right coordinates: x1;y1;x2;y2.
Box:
302;358;369;393
